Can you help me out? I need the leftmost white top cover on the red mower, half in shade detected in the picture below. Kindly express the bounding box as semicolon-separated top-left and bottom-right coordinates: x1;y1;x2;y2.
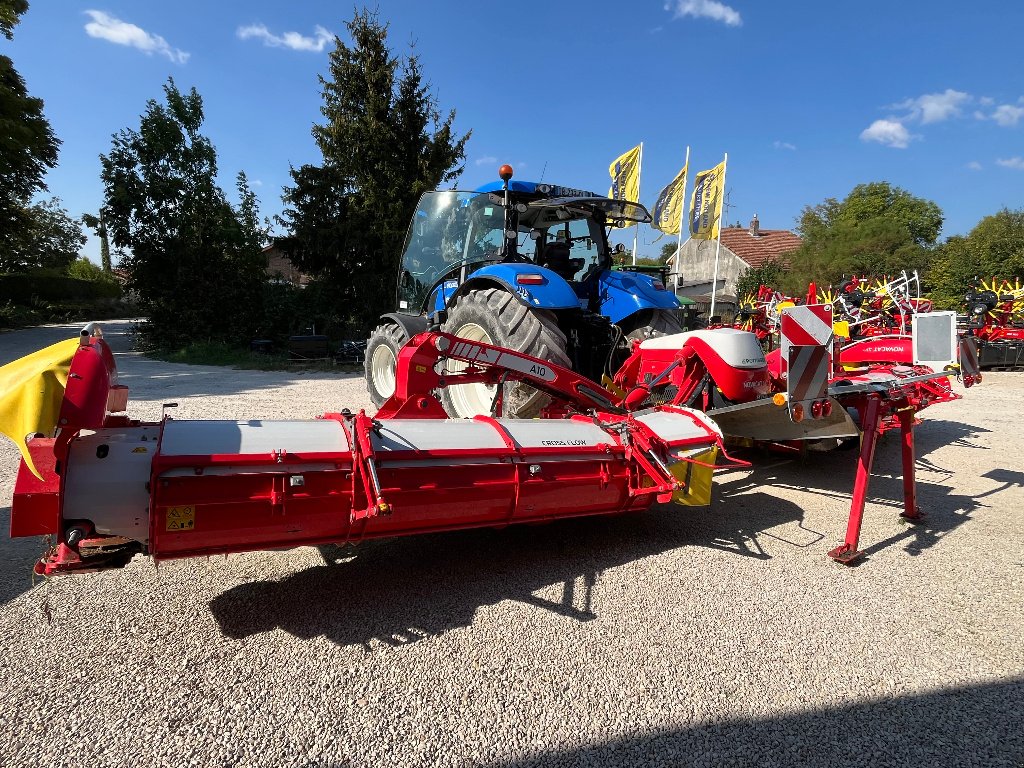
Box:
160;419;350;456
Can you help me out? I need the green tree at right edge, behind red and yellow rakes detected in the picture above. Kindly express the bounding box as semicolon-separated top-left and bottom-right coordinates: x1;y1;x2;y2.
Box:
928;209;1024;309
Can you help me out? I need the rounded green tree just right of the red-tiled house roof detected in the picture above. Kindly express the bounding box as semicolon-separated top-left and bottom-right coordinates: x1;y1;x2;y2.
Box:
785;181;942;291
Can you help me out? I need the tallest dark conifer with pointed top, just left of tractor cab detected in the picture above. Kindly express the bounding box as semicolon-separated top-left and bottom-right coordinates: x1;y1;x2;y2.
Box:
279;9;469;330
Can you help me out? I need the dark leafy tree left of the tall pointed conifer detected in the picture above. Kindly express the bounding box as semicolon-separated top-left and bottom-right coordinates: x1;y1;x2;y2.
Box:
100;80;266;347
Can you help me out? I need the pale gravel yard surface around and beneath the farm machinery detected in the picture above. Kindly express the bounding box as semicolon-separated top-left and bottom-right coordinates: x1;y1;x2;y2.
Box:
0;323;1024;768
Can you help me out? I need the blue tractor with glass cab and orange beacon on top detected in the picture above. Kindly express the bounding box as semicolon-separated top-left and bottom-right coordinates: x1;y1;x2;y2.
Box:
366;166;682;418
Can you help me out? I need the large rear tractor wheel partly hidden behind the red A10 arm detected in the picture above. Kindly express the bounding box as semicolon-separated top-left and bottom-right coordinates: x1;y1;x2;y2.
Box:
438;288;570;419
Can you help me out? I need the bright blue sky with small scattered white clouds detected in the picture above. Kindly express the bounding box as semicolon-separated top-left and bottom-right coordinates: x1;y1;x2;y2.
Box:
8;0;1024;260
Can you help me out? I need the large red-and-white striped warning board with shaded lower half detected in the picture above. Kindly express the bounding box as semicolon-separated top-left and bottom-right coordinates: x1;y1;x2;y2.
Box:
779;304;833;422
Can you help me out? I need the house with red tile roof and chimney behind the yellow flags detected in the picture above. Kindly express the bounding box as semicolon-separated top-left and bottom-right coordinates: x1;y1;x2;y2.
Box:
667;214;803;314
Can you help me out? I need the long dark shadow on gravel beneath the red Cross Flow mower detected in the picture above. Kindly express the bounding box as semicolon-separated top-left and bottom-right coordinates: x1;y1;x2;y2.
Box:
210;493;803;646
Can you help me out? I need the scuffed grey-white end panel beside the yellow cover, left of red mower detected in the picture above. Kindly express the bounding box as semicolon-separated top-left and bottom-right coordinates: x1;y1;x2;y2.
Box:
62;427;160;544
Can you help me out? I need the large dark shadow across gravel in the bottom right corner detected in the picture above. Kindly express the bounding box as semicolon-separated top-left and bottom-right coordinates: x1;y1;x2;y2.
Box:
481;678;1024;768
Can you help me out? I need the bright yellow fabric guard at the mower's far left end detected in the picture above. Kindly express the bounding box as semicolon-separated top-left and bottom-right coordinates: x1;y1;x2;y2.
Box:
0;339;79;479
